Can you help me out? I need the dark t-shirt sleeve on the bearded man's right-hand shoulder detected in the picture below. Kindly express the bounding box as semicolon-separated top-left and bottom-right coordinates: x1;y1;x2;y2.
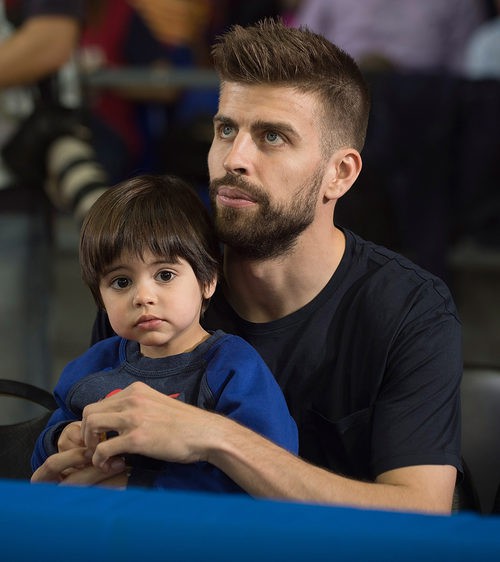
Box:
371;282;462;475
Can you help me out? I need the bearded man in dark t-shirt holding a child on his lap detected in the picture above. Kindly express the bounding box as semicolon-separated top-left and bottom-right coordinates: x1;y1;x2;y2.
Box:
33;21;461;512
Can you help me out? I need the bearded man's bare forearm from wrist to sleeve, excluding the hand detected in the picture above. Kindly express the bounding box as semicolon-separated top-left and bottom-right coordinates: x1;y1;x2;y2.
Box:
208;419;456;513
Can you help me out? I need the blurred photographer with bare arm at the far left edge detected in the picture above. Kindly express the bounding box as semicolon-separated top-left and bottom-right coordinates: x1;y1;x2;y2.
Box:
0;0;83;423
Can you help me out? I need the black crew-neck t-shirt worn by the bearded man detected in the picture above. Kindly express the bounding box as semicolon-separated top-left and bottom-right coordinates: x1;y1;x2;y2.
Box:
94;231;462;480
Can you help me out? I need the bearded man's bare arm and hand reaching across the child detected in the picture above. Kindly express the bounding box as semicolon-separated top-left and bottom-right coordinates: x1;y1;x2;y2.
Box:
82;383;456;513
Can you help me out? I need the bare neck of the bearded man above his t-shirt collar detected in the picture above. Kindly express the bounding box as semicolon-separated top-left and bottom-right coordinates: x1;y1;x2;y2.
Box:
224;223;345;323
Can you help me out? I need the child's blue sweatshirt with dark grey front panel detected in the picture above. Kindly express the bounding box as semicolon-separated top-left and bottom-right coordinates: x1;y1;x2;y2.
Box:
32;330;298;492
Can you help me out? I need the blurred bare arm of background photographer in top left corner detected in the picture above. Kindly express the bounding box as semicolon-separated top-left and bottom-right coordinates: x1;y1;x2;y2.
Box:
0;15;80;88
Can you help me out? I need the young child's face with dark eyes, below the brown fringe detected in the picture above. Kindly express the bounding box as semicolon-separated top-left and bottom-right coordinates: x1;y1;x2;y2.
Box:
99;248;216;357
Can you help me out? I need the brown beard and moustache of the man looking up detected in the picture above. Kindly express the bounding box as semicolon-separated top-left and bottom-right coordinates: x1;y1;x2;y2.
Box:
210;169;323;260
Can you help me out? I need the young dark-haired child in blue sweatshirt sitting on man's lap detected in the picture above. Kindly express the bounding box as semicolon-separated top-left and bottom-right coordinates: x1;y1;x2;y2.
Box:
32;176;298;492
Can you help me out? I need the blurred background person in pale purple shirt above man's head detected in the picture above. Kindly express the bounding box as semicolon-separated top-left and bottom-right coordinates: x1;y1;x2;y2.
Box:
293;0;485;74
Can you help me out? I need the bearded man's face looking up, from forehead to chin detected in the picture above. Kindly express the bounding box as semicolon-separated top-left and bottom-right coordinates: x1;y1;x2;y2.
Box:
208;83;324;259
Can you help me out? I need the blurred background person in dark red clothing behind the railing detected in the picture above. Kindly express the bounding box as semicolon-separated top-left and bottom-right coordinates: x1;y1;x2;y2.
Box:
78;0;176;185
